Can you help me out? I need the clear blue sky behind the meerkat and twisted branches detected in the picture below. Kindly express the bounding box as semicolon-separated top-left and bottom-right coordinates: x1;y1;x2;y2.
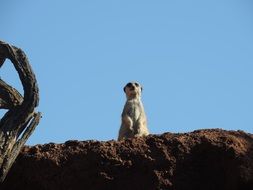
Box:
0;0;253;145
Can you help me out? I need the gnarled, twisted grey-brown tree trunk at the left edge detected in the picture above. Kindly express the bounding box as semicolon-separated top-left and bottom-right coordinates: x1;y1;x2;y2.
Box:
0;41;41;182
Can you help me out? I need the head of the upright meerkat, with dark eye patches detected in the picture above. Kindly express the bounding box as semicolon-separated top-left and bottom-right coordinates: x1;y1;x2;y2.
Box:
124;82;142;99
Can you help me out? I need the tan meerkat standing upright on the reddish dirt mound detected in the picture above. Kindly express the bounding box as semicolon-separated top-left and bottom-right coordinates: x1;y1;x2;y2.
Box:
118;82;149;140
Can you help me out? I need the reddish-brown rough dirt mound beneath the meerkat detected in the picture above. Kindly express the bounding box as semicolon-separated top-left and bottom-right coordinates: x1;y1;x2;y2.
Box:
1;129;253;190
